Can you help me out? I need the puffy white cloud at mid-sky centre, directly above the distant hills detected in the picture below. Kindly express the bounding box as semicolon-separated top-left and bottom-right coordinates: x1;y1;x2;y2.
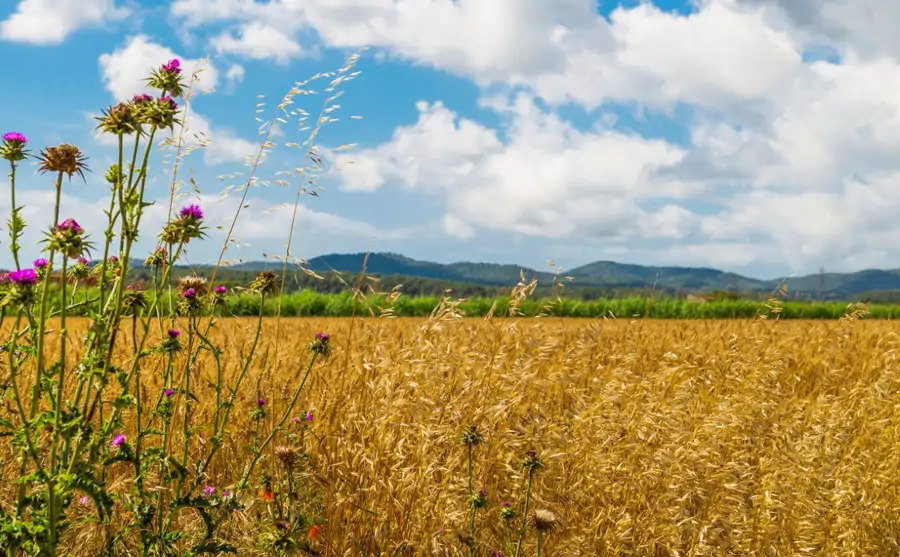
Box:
340;96;689;237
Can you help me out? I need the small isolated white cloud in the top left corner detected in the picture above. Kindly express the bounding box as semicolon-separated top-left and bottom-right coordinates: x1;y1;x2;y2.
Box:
0;0;130;45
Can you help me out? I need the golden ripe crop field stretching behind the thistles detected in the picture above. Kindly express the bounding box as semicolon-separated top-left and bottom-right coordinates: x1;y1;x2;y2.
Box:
2;308;900;556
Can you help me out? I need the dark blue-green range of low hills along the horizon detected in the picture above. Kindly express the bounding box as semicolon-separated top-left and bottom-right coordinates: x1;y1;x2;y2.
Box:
218;253;900;300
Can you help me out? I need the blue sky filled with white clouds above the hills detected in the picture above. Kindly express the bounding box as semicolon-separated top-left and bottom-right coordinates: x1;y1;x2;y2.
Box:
0;0;900;278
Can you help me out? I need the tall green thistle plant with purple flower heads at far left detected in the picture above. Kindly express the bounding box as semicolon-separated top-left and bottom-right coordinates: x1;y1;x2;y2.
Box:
0;53;344;556
